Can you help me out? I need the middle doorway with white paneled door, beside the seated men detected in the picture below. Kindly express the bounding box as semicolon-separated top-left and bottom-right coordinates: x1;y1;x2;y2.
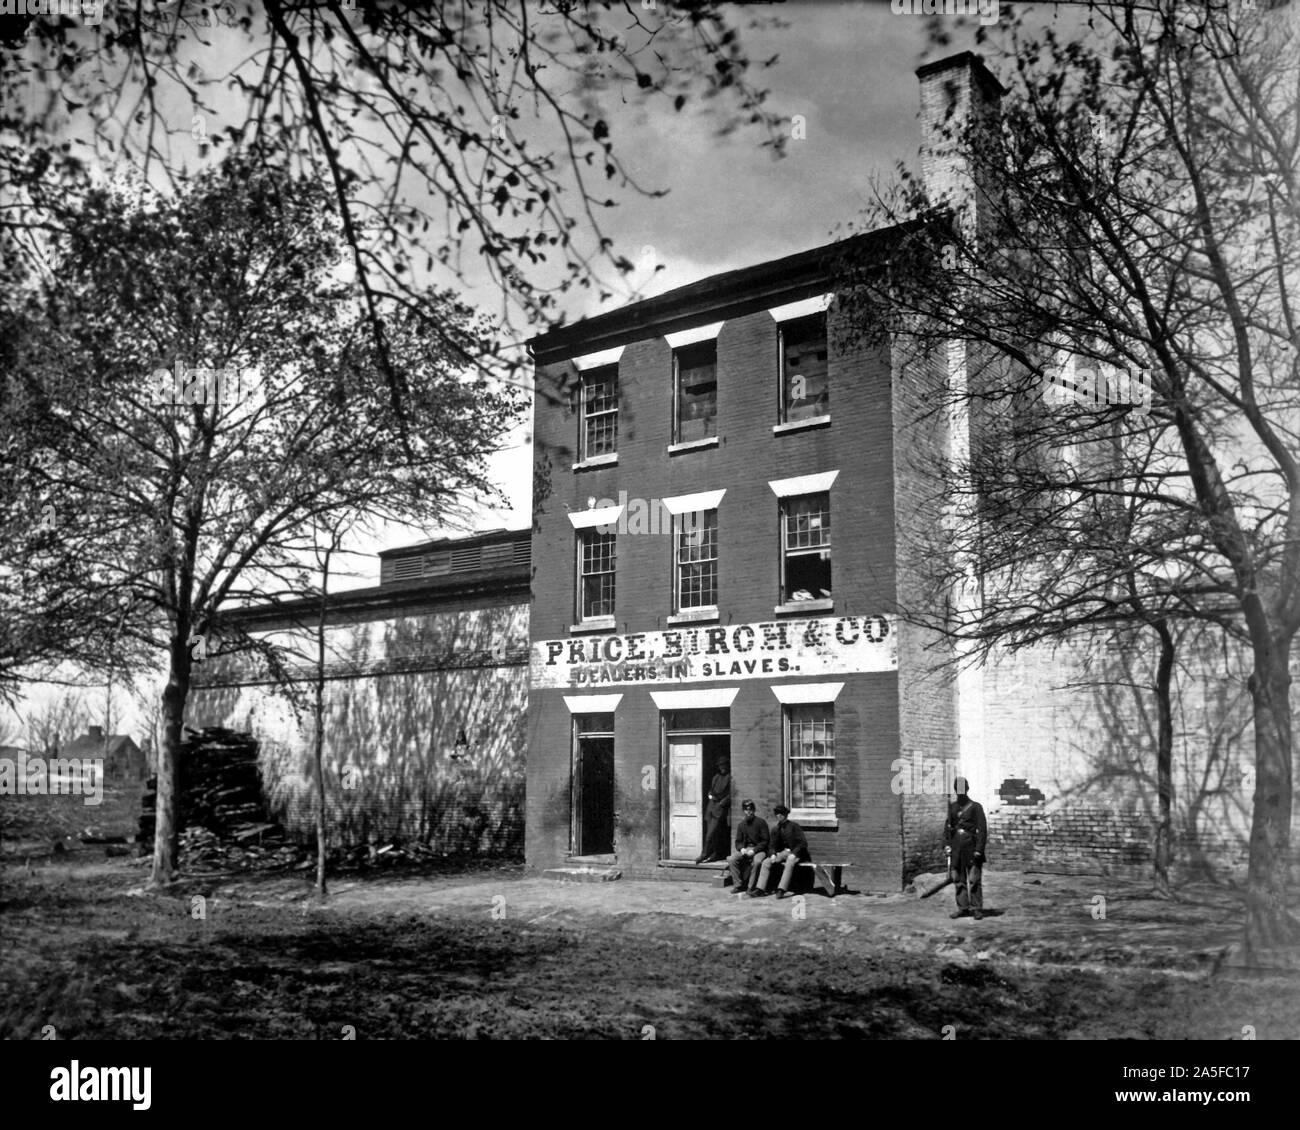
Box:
662;709;731;863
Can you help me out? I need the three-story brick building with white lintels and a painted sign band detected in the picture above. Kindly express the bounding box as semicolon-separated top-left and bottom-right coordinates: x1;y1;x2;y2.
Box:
525;55;992;891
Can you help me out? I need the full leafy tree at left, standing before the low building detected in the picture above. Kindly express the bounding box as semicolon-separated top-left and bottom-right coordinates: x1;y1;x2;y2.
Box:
1;161;517;884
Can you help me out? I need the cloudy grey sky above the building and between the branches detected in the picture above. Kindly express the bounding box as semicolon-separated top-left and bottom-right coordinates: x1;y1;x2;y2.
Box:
20;0;1008;577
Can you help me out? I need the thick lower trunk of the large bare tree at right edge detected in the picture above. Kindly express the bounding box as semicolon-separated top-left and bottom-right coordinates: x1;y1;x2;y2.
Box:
1245;638;1296;953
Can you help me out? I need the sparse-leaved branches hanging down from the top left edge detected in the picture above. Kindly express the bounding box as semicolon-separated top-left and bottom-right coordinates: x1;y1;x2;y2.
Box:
0;0;784;408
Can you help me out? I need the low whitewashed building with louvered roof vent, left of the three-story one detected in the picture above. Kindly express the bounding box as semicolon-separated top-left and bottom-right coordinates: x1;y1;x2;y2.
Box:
186;531;529;854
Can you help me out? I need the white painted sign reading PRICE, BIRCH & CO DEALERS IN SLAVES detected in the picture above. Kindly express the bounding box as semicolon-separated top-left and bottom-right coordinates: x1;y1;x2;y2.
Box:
529;616;898;690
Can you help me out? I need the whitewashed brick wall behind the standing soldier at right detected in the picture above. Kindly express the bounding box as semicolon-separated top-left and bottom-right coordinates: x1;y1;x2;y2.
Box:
972;635;1284;874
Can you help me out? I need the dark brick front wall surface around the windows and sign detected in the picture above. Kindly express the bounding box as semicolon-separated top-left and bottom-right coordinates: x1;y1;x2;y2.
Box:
527;295;928;891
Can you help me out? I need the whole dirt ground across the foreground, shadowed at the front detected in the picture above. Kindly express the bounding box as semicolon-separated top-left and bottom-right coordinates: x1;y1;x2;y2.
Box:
0;845;1300;1040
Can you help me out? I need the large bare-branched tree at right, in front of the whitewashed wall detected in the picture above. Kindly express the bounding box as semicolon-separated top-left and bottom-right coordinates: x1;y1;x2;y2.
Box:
857;0;1300;949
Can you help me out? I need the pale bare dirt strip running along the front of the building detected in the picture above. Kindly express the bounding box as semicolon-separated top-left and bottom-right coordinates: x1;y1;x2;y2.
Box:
217;873;1240;974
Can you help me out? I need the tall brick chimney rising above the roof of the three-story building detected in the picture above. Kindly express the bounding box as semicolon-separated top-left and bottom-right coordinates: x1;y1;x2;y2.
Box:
917;51;1006;238
